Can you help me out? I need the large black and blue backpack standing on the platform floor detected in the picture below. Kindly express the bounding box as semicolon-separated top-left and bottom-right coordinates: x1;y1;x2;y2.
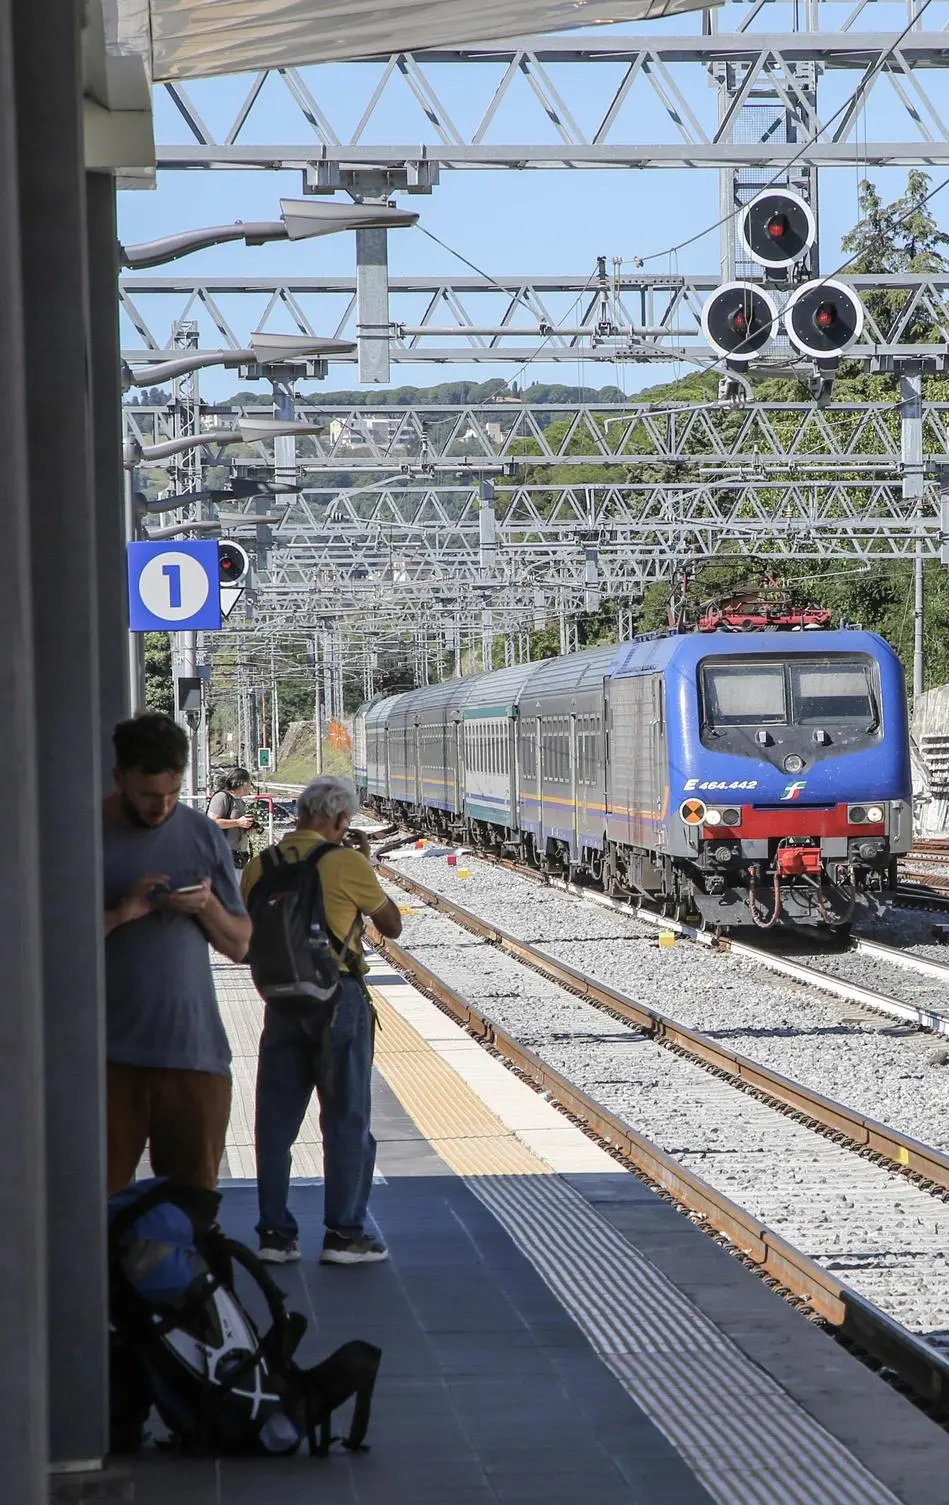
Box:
108;1178;382;1457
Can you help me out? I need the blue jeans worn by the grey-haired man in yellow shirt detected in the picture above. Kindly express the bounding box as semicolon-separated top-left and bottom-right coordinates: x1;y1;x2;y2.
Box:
254;975;376;1239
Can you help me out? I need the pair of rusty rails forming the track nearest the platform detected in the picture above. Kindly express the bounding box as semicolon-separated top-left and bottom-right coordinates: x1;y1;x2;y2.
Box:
369;867;949;1410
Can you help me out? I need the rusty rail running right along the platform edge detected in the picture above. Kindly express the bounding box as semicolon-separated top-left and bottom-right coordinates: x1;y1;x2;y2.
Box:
377;921;949;1410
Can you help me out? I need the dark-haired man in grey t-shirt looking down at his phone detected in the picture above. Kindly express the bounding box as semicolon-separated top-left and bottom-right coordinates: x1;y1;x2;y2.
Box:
102;713;251;1195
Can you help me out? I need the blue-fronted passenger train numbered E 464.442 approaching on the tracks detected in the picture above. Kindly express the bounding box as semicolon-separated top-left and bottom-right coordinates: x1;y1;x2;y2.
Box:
353;617;913;932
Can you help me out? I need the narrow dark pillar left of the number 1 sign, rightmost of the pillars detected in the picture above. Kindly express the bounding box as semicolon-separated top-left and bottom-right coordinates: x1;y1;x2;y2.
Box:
86;173;130;787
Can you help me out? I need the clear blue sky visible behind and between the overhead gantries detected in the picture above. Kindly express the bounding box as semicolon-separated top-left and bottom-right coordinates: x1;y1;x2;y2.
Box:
119;0;949;399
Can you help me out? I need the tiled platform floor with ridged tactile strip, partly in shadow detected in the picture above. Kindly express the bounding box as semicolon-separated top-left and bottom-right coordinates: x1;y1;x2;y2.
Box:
127;963;949;1505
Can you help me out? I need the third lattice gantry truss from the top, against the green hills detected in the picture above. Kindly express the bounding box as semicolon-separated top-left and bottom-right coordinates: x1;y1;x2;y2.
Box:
125;397;949;469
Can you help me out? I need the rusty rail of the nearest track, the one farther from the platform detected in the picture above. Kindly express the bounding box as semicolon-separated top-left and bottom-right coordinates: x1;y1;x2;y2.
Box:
379;862;949;1193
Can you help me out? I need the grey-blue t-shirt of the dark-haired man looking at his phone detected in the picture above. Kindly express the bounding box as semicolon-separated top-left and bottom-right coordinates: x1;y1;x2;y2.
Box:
102;805;245;1076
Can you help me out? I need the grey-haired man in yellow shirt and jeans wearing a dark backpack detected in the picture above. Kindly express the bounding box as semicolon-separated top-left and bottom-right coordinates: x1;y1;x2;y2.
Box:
241;774;402;1264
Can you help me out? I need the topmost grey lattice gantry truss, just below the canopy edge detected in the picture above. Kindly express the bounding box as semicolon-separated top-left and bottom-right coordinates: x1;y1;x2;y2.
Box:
156;26;949;173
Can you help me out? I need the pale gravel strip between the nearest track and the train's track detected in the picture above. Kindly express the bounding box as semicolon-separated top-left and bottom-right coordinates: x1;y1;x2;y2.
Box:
382;849;949;1151
